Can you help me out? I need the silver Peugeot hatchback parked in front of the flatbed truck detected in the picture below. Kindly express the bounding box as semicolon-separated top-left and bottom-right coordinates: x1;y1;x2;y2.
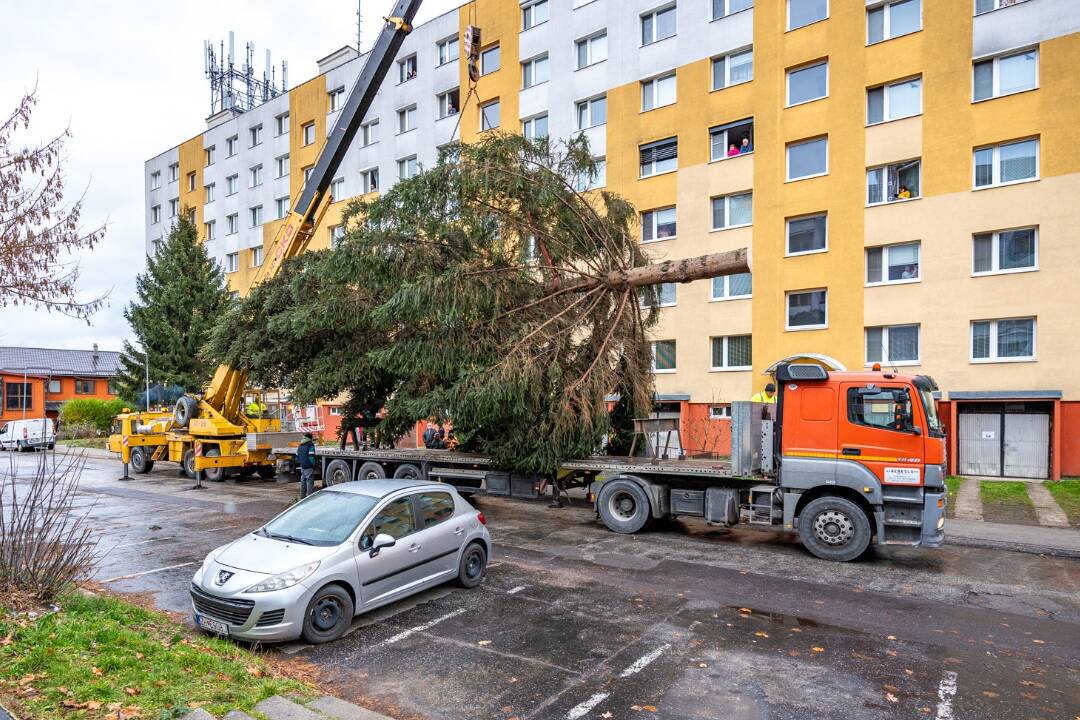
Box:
191;480;491;642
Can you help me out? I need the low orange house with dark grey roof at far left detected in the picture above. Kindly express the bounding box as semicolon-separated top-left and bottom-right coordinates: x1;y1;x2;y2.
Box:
0;343;120;422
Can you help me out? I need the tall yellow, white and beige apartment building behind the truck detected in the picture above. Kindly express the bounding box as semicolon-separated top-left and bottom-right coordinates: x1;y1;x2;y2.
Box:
146;0;1080;477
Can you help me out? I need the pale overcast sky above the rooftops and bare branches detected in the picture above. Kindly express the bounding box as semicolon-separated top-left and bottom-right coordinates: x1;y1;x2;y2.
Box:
0;0;462;350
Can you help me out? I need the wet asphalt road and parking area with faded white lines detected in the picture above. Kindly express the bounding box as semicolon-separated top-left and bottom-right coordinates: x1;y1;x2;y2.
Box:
21;456;1080;720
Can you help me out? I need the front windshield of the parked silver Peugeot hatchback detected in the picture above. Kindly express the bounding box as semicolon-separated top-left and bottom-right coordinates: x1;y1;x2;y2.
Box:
257;490;379;545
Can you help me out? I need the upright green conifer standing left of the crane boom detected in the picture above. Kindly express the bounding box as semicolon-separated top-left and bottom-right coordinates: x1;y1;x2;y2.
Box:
117;213;231;400
